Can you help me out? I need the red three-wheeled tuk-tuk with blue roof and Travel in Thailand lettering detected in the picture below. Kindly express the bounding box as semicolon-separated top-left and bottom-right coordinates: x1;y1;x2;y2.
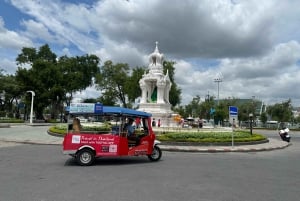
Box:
63;103;162;166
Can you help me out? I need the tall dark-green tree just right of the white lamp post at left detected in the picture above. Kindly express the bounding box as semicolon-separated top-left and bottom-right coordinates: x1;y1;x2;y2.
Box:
16;45;59;119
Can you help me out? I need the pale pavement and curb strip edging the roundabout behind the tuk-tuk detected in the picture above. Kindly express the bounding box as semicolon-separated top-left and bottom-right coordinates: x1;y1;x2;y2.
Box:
0;124;290;152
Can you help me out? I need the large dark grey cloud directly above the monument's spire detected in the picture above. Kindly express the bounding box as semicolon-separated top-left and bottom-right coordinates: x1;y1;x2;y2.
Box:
94;0;273;58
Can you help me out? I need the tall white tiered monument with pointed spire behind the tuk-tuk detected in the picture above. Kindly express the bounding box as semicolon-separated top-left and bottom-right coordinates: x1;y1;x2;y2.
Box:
138;42;173;127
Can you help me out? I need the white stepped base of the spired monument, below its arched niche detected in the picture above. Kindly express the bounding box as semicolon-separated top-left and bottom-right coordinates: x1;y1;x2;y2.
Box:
137;103;176;127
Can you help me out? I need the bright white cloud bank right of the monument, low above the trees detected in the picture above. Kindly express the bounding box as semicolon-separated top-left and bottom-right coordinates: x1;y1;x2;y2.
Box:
176;41;300;105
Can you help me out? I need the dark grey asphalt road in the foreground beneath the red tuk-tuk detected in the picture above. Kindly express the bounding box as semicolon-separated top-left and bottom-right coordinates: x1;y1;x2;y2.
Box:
0;142;300;201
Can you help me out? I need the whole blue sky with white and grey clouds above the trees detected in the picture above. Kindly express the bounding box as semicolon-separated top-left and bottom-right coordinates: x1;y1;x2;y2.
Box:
0;0;300;106
